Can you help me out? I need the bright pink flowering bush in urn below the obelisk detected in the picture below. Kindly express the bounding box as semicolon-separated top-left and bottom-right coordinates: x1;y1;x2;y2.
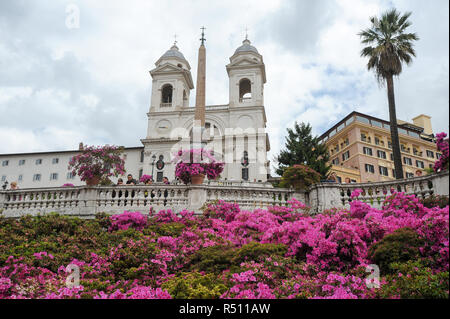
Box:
173;149;225;184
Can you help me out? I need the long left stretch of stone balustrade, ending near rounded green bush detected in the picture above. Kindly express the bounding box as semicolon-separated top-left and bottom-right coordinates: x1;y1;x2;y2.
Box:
0;182;305;218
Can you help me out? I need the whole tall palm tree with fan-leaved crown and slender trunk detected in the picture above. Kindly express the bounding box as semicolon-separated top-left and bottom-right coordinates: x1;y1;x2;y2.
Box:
358;9;419;179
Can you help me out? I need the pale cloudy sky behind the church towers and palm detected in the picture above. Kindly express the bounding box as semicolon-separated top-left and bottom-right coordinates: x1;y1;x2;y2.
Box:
0;0;449;170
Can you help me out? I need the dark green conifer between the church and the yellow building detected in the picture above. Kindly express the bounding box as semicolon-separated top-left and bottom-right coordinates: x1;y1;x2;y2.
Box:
276;122;331;178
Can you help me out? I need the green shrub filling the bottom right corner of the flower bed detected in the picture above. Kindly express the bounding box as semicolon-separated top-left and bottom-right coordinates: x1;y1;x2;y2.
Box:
379;261;449;299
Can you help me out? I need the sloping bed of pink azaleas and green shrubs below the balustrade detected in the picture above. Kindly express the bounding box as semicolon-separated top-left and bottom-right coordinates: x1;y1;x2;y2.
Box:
0;192;449;299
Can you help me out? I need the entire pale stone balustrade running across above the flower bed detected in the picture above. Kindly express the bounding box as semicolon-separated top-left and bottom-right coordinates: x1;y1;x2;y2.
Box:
0;171;449;218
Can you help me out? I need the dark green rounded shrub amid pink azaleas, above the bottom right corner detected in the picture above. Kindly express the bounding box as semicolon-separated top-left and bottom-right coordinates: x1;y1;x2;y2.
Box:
369;228;424;274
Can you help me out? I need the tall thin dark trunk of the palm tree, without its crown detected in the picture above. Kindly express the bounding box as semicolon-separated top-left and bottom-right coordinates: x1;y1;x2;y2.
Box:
386;75;403;179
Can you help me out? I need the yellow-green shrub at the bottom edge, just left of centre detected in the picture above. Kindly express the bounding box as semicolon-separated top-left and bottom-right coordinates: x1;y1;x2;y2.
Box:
161;272;228;299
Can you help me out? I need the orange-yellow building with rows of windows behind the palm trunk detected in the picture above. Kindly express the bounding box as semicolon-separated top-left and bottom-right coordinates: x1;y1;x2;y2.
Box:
320;112;441;183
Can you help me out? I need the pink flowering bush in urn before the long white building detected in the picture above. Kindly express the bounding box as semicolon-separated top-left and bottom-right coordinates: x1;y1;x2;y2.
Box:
68;145;125;181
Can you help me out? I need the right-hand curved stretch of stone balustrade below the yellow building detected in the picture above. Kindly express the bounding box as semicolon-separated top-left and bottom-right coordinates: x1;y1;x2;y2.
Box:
308;171;449;212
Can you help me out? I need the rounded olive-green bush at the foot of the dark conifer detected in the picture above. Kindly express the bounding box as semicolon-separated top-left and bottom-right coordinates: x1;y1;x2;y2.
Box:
280;165;320;190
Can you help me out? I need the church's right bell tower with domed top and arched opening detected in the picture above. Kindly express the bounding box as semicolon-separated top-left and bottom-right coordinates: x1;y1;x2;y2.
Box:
227;36;266;107
